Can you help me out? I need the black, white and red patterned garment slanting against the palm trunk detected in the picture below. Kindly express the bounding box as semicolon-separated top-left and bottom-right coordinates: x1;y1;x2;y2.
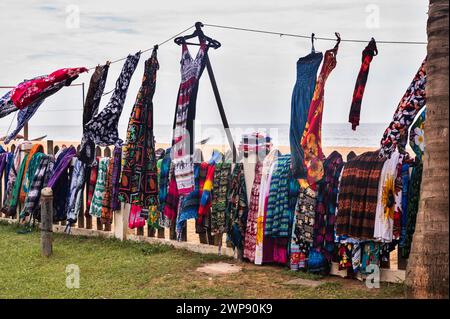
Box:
380;59;427;157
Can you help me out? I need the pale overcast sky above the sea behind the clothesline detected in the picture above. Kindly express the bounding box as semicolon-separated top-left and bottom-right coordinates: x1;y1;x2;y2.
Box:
0;0;428;132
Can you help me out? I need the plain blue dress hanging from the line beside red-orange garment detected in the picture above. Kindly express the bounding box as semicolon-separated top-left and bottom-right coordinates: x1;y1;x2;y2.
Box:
289;52;323;178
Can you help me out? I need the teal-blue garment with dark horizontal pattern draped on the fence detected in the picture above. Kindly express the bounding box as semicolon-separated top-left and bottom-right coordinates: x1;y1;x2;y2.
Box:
264;155;291;238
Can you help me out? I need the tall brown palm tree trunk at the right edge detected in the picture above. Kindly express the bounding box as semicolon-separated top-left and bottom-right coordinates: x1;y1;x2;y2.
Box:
406;0;449;298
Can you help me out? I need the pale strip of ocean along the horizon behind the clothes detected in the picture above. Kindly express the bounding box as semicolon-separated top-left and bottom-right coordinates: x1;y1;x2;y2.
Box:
0;123;386;147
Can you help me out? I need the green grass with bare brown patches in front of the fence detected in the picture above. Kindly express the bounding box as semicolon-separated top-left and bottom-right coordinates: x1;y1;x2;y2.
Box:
0;224;403;298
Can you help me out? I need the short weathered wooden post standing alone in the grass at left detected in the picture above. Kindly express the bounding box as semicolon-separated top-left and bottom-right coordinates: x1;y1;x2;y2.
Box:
41;187;53;257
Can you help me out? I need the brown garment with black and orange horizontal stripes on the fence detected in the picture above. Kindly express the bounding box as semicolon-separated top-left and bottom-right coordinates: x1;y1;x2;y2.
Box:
336;151;385;239
